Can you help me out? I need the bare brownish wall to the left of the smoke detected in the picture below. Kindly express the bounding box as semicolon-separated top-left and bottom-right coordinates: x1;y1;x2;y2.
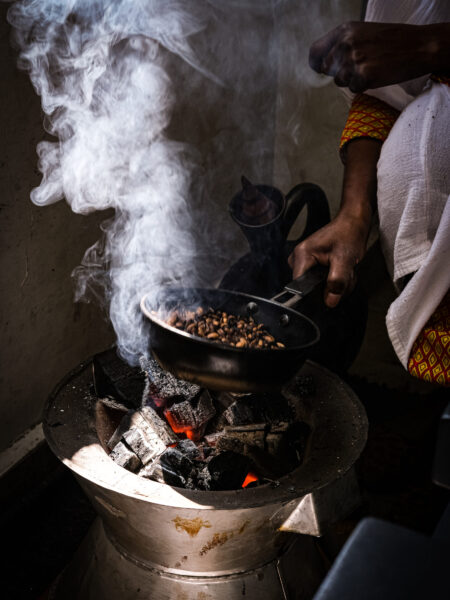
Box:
0;3;113;450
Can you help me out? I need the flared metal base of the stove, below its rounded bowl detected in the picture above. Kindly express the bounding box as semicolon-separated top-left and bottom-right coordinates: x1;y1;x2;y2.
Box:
49;519;325;600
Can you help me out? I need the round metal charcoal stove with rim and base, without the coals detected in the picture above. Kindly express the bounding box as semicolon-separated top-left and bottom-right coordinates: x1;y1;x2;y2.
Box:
44;363;367;600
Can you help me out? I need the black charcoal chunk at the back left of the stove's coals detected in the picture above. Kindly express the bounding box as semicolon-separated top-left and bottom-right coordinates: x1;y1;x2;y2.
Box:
92;348;145;408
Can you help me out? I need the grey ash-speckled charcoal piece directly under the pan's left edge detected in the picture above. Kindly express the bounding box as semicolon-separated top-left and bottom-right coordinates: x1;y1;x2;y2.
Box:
140;357;201;404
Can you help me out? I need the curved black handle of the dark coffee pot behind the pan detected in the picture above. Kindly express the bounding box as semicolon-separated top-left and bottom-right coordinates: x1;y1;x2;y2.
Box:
283;183;330;244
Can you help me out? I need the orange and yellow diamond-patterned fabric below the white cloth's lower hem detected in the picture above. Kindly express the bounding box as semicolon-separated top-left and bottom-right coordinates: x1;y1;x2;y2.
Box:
408;291;450;386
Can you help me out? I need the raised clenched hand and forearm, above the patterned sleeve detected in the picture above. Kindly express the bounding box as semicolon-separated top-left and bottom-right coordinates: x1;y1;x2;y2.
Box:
309;22;450;93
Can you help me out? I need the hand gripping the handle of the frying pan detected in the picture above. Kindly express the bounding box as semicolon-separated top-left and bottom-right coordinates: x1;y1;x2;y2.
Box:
288;215;370;308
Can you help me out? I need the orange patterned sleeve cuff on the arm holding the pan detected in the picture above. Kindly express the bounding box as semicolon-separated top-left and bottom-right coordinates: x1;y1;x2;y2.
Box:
339;94;400;159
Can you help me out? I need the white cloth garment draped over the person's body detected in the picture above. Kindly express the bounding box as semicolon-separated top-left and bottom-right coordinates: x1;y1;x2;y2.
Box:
366;0;450;368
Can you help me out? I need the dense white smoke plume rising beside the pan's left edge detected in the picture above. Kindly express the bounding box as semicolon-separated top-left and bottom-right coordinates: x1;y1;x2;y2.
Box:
8;0;243;362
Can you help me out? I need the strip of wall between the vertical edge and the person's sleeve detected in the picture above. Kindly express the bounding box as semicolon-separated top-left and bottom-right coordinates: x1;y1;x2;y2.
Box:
274;0;361;225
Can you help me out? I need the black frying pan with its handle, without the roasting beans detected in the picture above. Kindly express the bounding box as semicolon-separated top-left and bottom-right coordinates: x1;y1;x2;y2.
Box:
141;267;327;392
